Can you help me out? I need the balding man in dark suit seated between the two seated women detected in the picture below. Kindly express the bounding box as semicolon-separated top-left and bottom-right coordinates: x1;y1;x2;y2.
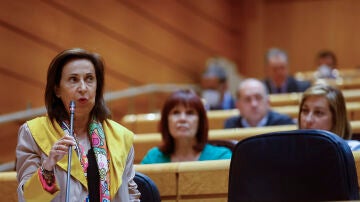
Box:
224;78;294;128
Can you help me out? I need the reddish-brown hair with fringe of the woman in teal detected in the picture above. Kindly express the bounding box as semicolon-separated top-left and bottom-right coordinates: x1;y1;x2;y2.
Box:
159;89;209;154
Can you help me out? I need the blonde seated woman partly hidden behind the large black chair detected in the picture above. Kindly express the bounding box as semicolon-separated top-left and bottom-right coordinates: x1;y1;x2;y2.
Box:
298;84;360;151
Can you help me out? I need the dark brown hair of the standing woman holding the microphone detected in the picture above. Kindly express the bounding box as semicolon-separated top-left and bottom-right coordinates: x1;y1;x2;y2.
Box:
45;48;110;122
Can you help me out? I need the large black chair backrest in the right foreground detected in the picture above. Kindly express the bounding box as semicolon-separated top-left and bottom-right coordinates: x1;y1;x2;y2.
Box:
228;130;359;202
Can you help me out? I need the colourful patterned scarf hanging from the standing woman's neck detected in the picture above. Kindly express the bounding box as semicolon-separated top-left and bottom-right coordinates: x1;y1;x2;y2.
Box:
61;119;110;202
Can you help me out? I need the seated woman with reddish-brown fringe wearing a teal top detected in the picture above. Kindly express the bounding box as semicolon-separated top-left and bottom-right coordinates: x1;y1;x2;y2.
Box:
141;90;232;164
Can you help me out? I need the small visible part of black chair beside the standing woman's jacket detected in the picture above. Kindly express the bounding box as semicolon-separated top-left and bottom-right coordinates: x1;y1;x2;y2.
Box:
134;172;161;202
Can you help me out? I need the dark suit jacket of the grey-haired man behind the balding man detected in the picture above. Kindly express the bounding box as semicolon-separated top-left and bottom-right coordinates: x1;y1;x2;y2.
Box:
264;76;311;94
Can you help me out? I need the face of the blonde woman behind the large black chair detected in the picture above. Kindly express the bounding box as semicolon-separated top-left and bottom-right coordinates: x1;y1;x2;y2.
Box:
300;96;333;131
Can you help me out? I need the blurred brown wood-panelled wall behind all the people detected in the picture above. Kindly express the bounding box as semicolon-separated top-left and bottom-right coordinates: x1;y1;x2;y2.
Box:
0;0;360;163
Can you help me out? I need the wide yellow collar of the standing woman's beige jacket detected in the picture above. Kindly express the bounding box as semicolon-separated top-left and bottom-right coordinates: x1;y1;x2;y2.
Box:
27;116;133;198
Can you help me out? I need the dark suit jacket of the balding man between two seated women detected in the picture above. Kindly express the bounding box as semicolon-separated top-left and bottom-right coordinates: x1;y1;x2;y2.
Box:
224;110;295;128
